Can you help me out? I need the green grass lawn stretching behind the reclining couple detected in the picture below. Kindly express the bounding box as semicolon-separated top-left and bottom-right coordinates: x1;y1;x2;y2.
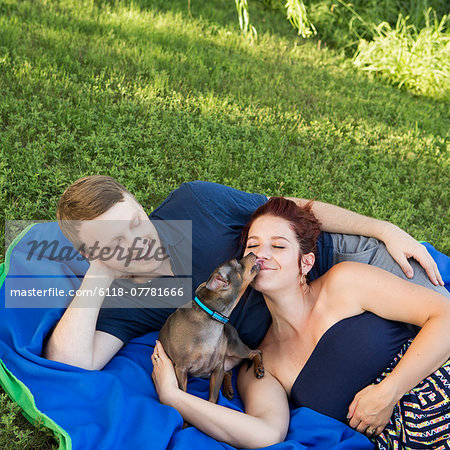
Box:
0;0;450;446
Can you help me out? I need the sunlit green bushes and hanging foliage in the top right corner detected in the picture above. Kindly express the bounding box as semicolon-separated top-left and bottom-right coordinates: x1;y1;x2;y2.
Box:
230;0;450;99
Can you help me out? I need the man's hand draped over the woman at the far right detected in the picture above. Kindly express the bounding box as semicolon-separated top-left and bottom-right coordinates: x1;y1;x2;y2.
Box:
382;223;444;286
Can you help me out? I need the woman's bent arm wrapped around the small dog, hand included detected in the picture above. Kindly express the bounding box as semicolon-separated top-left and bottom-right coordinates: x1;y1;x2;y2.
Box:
152;342;290;448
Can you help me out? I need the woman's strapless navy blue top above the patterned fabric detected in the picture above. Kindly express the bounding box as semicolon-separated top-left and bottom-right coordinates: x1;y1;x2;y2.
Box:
291;312;413;423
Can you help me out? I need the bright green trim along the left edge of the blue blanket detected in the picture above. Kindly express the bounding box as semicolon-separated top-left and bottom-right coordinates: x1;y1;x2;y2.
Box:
0;223;72;450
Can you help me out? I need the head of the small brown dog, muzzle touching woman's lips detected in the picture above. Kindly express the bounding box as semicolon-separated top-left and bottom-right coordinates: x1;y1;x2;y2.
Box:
196;253;260;304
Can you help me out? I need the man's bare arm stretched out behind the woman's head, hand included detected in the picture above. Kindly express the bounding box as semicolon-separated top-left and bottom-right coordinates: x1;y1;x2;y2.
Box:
287;197;444;286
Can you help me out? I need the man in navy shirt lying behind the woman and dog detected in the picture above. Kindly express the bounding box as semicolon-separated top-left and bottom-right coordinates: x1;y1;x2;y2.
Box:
44;175;448;370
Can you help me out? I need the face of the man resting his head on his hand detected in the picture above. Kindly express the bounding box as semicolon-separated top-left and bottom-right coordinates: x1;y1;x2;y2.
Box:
79;194;167;275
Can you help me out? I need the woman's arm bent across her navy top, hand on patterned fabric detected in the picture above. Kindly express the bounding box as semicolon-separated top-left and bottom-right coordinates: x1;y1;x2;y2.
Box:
329;262;450;433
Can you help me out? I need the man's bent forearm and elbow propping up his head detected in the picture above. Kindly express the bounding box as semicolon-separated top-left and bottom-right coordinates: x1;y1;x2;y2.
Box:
44;262;123;370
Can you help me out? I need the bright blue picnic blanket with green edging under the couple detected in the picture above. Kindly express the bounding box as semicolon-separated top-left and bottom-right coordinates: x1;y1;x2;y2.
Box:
0;222;450;450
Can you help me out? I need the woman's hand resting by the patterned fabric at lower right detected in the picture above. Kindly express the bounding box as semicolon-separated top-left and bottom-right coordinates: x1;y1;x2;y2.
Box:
347;383;396;437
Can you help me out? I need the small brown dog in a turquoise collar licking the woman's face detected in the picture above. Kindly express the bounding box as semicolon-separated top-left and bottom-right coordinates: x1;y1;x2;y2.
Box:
158;253;264;403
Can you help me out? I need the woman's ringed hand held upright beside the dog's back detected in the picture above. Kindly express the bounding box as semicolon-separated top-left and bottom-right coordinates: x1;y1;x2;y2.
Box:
152;341;179;405
